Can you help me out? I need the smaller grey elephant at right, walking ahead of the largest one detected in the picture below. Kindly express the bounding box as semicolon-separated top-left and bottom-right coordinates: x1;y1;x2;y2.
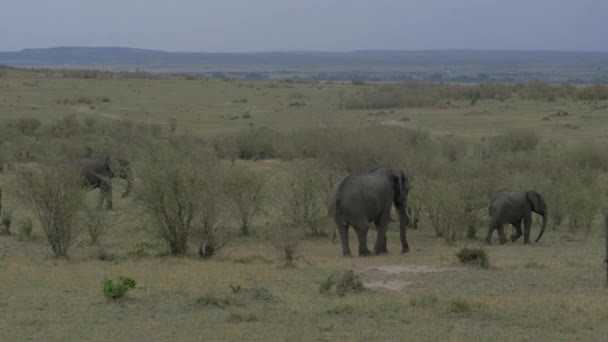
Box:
486;190;548;245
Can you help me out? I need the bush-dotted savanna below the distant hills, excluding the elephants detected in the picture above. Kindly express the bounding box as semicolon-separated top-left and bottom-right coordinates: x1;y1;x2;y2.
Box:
0;69;608;340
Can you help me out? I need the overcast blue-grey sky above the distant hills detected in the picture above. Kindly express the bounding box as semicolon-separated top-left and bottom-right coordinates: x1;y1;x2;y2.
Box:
0;0;608;52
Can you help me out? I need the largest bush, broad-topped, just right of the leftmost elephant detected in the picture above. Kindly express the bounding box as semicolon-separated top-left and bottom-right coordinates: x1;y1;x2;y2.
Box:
135;148;217;255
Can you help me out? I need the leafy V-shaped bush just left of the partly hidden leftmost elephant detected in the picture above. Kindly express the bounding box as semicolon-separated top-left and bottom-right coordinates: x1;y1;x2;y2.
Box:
17;162;84;257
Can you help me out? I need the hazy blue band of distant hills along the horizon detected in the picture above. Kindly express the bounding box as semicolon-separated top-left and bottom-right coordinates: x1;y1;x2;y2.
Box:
0;47;608;83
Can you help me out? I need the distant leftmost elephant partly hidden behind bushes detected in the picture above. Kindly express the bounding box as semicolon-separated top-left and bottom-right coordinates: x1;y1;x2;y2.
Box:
70;156;133;209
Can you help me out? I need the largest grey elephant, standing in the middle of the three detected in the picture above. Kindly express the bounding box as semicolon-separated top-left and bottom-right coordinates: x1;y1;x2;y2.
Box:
329;168;410;256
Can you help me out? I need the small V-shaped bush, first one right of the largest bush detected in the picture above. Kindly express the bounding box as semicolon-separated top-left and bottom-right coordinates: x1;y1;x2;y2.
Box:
224;166;269;235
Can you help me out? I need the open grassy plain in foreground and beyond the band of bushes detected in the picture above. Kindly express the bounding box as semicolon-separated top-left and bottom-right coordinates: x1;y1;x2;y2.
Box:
0;70;608;341
